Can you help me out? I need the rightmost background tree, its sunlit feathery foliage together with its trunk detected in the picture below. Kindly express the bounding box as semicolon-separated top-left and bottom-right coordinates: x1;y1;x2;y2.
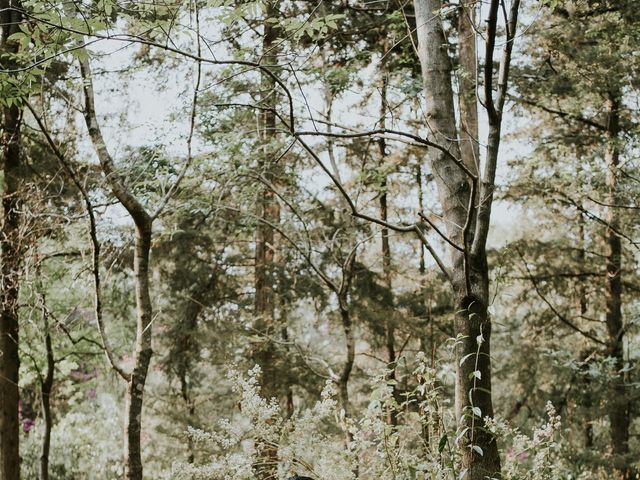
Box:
513;1;638;478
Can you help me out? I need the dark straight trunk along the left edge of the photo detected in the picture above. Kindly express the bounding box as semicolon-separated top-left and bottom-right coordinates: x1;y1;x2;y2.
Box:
0;0;23;480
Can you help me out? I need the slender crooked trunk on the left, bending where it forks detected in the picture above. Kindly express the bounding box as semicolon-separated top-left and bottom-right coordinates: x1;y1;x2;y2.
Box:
80;52;157;480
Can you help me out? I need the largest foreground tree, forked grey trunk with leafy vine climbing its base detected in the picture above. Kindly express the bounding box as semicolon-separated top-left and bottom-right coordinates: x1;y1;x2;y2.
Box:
414;0;519;479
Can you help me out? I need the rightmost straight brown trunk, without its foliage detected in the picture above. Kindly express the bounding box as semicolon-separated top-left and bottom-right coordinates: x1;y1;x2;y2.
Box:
604;93;631;479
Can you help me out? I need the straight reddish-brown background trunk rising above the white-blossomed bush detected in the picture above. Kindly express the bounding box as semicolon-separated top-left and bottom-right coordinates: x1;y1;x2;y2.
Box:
252;0;287;480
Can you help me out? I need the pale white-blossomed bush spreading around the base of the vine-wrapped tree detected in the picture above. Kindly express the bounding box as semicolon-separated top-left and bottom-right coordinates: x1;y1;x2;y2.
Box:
172;356;572;480
